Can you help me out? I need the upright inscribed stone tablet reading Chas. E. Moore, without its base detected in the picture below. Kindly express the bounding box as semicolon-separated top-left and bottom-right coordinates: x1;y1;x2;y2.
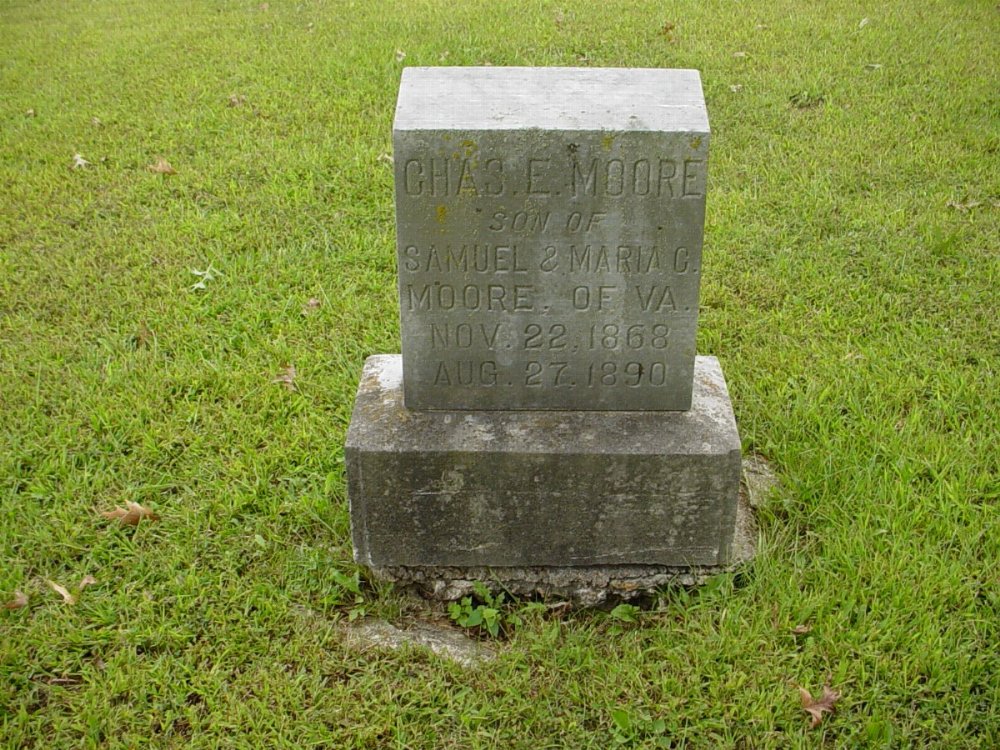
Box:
393;67;709;410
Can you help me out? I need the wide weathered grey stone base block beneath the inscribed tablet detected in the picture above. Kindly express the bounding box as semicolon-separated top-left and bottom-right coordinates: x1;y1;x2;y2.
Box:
346;355;740;569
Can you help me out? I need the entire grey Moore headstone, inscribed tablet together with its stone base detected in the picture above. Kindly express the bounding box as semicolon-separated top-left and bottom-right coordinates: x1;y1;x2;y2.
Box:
346;68;740;604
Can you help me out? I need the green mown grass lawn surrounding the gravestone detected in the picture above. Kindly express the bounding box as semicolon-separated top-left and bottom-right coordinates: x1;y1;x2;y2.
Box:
0;0;1000;748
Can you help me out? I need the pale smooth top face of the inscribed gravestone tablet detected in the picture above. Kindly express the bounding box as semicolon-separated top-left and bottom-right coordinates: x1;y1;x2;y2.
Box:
393;67;708;133
